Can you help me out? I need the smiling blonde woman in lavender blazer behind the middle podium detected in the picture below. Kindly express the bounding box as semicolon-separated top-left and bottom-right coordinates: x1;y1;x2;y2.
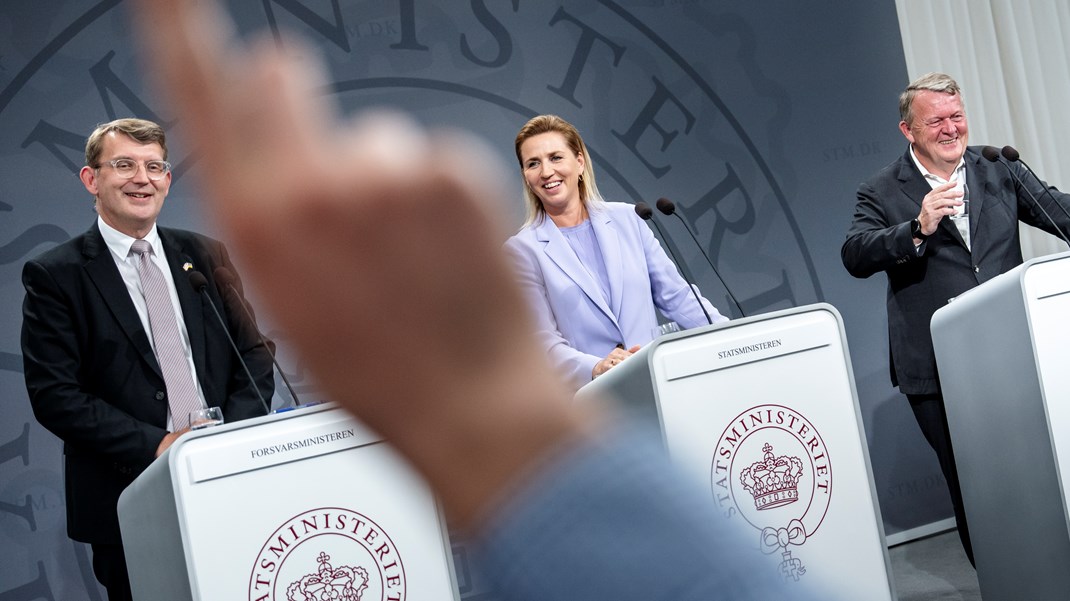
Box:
505;115;728;389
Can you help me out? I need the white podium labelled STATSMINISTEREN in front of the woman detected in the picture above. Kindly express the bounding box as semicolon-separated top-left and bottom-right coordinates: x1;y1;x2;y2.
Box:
577;304;896;601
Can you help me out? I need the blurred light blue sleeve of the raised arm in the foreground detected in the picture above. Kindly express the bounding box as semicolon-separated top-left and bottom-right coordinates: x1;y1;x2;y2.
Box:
474;425;829;601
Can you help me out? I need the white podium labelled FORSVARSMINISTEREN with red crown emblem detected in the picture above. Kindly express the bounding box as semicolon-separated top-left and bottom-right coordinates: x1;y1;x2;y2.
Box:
119;404;458;601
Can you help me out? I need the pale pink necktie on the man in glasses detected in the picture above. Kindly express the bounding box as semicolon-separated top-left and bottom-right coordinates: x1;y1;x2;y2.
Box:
131;240;201;430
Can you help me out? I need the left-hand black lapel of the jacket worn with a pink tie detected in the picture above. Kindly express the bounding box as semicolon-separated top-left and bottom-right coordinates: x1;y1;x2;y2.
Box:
82;224;164;379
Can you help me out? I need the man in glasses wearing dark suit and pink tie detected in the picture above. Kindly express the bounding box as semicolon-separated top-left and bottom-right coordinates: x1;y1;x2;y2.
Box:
22;119;274;601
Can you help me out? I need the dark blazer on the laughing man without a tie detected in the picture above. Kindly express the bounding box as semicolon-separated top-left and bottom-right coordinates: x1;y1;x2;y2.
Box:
840;147;1070;395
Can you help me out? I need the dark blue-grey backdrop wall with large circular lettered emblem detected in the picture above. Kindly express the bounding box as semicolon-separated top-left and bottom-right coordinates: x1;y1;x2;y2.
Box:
0;0;950;601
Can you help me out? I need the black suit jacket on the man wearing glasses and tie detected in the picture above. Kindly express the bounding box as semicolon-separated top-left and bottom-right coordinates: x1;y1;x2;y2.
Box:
22;224;274;543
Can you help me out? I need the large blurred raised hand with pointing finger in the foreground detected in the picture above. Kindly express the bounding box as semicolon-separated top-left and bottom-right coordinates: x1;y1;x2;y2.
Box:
135;0;590;526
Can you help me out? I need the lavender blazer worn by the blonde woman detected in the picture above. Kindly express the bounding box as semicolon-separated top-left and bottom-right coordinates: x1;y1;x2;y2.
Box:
505;202;728;389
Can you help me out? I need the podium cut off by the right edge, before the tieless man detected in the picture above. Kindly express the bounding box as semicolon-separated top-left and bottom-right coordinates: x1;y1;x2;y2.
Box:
931;253;1070;601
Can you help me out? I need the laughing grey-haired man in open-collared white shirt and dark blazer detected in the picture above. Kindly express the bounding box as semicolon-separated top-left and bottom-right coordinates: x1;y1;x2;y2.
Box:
840;73;1070;563
